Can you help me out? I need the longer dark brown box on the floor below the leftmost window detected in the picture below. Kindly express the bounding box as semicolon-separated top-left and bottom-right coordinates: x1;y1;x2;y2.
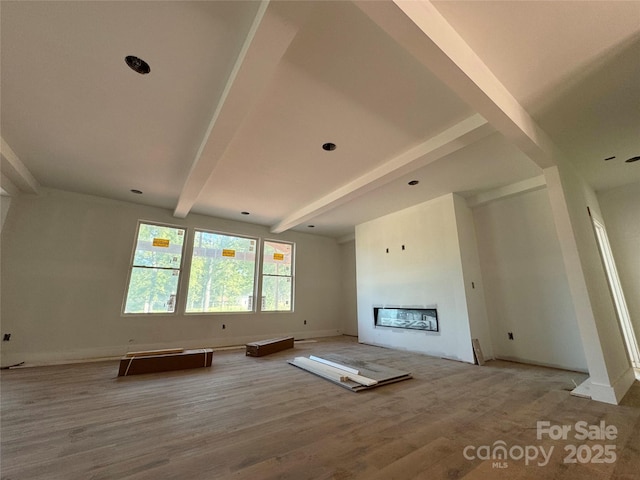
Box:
118;348;213;377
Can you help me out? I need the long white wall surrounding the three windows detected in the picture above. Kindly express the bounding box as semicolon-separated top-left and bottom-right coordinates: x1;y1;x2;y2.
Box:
1;190;343;365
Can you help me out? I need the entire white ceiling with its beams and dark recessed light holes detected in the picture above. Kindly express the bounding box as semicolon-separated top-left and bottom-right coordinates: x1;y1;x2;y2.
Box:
0;0;640;237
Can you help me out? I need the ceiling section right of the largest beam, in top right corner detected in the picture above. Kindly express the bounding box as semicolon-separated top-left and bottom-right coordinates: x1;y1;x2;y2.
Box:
434;0;640;190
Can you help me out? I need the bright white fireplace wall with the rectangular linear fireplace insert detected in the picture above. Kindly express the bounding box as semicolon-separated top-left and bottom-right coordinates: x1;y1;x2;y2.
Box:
356;194;474;362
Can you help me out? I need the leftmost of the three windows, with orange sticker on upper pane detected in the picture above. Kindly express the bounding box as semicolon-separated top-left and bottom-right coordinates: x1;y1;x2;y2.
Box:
124;223;185;313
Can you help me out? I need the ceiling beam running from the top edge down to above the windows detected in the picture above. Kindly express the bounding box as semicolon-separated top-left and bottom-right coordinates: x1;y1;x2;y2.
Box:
173;0;297;218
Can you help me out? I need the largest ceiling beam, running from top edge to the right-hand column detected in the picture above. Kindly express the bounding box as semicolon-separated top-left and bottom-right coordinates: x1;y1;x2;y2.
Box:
355;0;557;168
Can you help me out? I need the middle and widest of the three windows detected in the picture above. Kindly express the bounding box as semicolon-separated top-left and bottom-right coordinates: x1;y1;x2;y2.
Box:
186;230;257;313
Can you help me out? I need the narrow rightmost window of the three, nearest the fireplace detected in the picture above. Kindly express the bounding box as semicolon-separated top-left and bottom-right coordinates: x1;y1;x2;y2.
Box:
262;240;293;312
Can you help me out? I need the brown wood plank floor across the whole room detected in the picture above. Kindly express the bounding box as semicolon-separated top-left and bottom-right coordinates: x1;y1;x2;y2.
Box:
0;337;640;480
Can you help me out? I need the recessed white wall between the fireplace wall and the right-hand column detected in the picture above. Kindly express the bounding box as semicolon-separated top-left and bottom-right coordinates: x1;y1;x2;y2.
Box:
474;189;587;371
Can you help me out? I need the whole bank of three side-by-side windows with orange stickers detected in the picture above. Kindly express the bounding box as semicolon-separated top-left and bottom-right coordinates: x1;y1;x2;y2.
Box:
124;222;295;314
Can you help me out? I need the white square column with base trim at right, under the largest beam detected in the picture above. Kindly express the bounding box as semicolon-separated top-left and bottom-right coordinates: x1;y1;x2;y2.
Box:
544;161;635;404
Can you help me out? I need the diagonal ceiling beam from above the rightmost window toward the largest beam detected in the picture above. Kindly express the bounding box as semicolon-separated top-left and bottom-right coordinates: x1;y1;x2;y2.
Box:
271;114;494;233
